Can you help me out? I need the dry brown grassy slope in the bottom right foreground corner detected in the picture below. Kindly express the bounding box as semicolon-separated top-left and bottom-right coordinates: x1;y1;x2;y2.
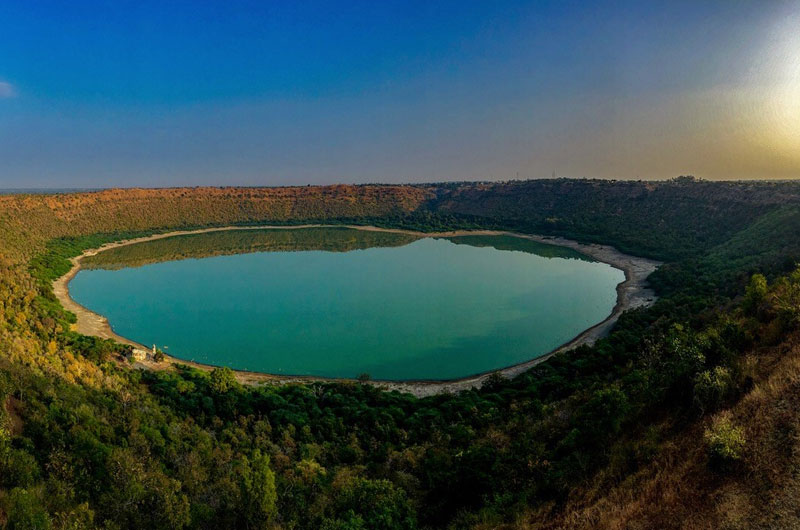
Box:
509;336;800;530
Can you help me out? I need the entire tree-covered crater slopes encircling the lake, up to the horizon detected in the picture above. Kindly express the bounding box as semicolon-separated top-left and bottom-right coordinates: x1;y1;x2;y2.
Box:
0;177;800;529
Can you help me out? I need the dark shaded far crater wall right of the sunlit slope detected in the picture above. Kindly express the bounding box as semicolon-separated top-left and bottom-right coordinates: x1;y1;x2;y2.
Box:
435;177;800;260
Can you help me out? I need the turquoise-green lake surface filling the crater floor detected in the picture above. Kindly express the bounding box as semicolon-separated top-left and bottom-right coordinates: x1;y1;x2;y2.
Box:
69;228;624;380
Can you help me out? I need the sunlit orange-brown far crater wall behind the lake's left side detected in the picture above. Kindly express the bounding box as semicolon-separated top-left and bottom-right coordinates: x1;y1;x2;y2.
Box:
0;186;430;260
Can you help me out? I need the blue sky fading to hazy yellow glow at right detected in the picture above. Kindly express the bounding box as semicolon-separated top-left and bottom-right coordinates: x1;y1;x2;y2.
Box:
0;0;800;188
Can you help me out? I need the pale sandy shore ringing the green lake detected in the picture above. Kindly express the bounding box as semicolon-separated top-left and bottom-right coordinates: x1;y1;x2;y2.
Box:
53;224;661;397
